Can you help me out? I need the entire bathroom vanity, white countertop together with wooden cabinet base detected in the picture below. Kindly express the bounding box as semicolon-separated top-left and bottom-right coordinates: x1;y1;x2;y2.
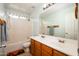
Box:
30;35;78;56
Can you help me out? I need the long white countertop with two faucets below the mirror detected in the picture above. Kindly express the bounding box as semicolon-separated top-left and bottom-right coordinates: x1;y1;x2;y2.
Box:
30;35;78;56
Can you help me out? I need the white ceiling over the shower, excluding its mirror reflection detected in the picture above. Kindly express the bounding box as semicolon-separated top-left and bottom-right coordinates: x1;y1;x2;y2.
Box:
8;3;43;14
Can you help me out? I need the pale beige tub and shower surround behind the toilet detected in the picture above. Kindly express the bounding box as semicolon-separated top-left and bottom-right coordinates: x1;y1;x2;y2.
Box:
6;17;32;52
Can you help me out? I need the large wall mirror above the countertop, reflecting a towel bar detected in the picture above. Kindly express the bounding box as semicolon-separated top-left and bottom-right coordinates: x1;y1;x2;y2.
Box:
40;3;78;39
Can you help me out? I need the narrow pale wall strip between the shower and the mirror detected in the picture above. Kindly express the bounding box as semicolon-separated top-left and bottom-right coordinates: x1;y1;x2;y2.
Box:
30;6;43;35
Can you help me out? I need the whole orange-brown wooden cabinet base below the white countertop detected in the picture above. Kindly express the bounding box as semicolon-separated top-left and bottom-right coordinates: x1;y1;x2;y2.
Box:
30;39;67;56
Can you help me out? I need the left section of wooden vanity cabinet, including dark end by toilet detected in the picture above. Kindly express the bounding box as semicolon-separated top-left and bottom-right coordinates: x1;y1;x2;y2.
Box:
30;39;41;56
